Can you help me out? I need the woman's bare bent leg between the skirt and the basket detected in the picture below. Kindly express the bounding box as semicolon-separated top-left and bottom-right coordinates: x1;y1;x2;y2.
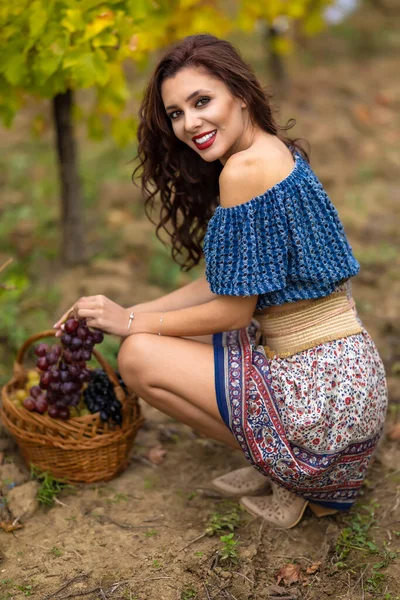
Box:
118;334;240;450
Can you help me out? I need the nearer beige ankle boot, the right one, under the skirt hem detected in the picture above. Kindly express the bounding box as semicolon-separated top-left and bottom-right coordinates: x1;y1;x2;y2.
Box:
240;483;308;529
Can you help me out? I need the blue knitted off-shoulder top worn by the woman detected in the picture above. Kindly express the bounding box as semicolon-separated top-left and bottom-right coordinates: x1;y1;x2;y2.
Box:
204;152;360;309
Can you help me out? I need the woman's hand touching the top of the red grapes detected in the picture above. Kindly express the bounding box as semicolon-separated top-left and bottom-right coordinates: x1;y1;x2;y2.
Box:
54;295;129;337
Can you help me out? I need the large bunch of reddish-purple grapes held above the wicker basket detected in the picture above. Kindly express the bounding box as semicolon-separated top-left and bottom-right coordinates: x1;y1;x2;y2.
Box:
23;319;103;420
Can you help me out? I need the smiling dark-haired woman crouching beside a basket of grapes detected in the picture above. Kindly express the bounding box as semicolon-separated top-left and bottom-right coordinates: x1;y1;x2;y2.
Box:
56;35;387;528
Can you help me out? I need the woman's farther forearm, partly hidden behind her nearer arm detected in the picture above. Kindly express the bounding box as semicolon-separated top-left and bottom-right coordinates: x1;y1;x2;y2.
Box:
128;275;217;313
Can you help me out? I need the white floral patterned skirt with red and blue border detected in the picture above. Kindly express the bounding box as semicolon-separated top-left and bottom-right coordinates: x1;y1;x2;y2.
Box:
213;322;387;510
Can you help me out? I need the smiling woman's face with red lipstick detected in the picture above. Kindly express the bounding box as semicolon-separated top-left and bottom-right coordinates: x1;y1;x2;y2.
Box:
161;67;249;164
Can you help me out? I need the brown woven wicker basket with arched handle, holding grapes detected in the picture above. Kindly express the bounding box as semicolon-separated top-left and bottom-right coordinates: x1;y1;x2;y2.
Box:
0;330;143;483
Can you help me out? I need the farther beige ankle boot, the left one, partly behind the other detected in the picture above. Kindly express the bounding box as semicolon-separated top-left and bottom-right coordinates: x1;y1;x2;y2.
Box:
210;467;271;498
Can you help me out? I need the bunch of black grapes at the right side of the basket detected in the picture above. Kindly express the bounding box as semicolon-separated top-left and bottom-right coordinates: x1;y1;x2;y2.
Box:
83;369;122;425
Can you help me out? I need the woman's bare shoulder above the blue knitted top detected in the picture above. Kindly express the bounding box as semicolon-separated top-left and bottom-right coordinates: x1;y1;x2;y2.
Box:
219;147;294;207
